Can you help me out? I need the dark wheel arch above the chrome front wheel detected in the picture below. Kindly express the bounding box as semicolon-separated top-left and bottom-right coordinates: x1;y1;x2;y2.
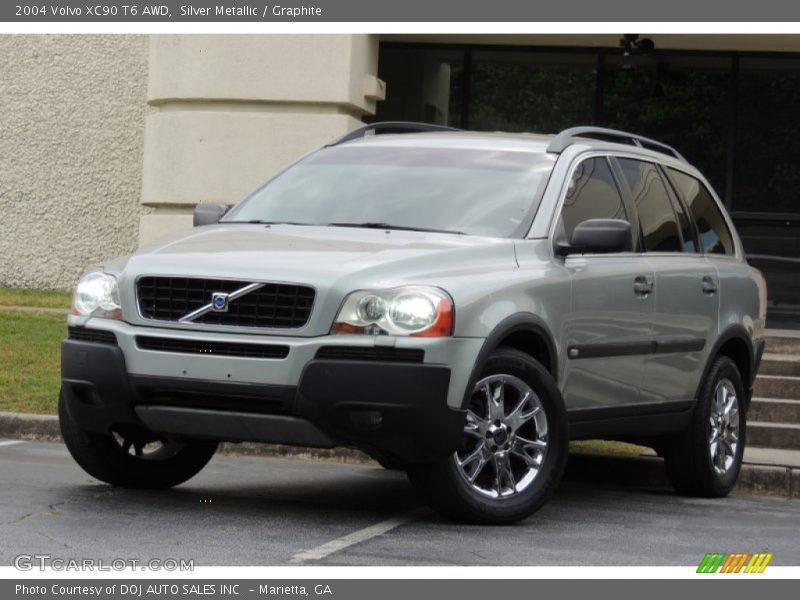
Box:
462;313;558;407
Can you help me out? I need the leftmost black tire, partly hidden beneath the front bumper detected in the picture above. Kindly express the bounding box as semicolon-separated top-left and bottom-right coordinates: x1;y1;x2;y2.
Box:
58;390;217;489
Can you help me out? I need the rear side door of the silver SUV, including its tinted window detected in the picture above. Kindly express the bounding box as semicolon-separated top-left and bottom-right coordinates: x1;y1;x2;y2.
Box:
616;158;719;410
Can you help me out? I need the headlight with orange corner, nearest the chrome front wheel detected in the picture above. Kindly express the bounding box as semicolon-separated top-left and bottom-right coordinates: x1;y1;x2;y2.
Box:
331;286;453;337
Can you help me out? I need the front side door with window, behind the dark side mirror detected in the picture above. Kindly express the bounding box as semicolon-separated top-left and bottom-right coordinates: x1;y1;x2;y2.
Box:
553;156;654;412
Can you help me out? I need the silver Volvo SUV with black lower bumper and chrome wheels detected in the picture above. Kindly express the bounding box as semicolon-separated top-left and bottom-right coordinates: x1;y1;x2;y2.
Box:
60;123;766;523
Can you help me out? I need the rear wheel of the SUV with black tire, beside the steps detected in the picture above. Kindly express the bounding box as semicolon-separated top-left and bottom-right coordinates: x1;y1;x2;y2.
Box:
664;356;747;498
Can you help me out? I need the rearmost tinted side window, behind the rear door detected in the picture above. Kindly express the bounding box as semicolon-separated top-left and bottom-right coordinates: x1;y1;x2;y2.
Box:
669;169;734;254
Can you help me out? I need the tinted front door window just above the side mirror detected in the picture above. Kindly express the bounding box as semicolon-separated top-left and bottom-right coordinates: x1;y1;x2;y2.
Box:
557;157;628;247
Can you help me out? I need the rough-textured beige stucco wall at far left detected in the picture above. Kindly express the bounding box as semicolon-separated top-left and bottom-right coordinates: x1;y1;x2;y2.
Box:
0;35;149;289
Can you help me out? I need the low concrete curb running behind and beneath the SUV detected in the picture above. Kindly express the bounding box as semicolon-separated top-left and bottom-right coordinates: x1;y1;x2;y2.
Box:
0;412;800;499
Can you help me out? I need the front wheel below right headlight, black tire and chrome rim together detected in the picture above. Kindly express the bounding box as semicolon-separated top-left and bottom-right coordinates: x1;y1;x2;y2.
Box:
408;348;569;525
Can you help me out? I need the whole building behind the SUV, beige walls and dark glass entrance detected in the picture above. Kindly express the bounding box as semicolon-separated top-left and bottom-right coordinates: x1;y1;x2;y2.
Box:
0;35;800;326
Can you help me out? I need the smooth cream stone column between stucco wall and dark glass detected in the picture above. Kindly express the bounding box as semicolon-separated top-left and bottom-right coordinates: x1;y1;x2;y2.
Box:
139;35;385;244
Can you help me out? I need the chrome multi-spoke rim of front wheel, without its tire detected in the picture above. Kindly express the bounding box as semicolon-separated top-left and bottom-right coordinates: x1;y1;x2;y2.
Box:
453;375;547;498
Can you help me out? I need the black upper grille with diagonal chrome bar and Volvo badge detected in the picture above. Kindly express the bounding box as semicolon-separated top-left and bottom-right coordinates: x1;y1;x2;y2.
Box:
136;277;315;329
